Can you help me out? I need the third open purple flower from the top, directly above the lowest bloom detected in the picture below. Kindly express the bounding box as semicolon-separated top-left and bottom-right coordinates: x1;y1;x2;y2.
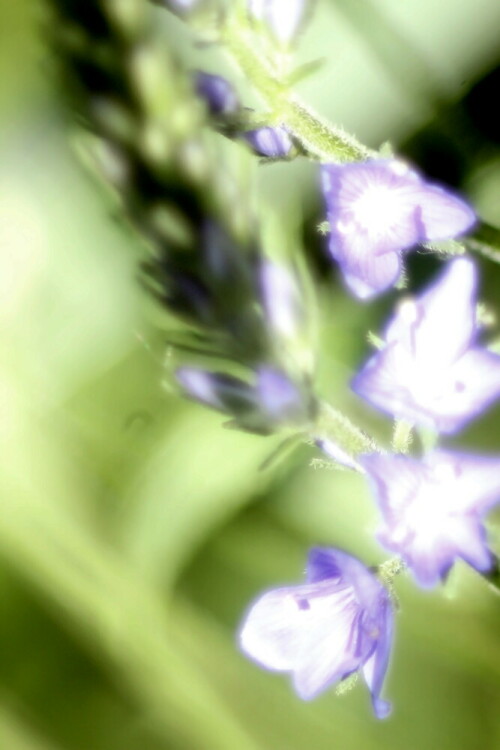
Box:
359;451;500;587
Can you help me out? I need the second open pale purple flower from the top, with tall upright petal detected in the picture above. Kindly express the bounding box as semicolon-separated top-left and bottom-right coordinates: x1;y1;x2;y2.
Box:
351;258;500;433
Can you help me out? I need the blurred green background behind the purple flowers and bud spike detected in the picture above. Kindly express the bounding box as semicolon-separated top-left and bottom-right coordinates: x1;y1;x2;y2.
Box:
0;0;500;750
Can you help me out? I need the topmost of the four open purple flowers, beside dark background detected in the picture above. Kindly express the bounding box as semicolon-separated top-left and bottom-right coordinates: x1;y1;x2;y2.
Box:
322;159;476;299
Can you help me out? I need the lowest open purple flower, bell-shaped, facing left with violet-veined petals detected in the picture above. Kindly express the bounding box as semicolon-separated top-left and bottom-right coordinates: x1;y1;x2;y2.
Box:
240;548;393;718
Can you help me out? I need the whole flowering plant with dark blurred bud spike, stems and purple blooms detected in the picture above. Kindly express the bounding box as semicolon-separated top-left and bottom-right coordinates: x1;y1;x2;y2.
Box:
60;0;500;718
